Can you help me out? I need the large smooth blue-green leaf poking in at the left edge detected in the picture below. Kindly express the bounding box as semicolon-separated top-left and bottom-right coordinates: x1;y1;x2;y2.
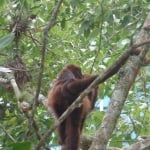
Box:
0;33;15;49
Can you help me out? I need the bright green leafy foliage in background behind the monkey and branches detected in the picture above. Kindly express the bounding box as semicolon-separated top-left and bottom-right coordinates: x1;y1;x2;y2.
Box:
0;0;150;150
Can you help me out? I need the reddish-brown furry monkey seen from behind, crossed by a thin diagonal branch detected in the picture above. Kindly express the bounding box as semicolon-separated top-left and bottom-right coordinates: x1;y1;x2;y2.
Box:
48;65;98;150
